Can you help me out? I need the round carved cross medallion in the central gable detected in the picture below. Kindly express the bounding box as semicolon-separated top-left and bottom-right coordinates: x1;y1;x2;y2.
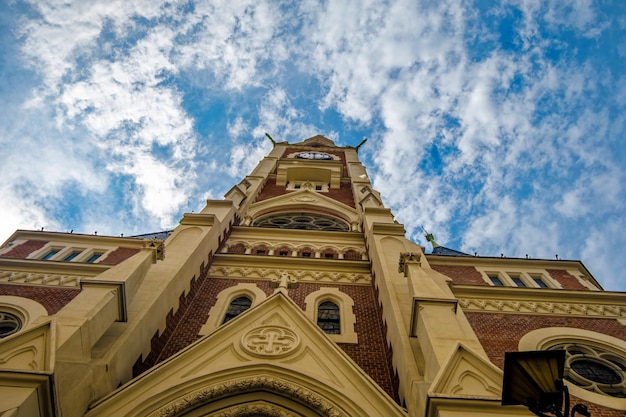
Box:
241;326;300;357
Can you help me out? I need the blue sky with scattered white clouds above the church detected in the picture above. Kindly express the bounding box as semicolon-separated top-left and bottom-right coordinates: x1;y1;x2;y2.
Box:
0;0;626;290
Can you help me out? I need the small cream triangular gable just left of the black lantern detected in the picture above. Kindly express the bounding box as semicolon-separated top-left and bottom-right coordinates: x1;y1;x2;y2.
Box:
428;343;502;399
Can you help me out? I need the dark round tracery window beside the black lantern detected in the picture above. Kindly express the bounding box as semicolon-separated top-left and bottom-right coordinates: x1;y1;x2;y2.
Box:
550;343;626;398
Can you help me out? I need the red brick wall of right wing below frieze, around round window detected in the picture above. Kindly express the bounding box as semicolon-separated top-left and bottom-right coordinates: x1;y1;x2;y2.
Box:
465;312;626;417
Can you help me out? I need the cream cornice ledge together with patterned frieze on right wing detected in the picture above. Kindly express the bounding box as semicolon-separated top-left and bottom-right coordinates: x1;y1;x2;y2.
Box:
452;285;626;318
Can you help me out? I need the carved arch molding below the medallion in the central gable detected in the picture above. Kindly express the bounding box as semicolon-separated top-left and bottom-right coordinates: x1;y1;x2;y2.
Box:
149;376;348;417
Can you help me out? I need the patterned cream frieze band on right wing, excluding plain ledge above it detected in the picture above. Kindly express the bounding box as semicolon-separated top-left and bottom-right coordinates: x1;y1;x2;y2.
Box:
459;298;626;318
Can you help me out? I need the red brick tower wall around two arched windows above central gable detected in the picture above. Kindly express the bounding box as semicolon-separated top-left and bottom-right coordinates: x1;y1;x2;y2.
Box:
141;278;398;400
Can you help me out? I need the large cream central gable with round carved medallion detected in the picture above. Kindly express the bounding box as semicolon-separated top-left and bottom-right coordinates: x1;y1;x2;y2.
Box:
87;292;407;417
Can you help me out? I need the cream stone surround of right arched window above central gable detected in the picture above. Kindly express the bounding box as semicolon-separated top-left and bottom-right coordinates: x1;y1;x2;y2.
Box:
304;287;358;343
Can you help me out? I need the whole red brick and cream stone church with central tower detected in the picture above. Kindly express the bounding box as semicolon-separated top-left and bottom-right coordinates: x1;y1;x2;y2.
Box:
0;136;626;417
